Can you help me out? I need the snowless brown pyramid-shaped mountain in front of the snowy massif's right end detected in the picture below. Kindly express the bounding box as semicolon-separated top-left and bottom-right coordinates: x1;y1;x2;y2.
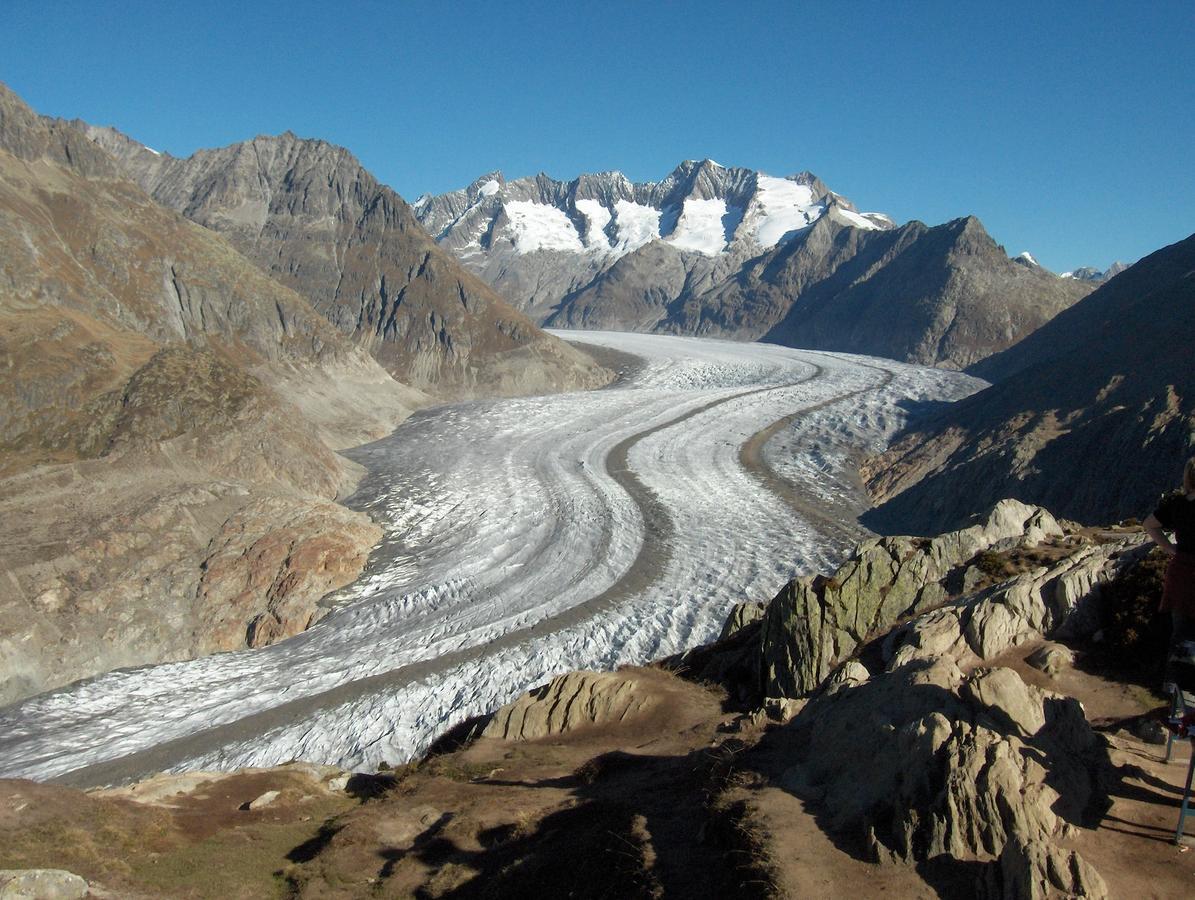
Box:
674;208;1090;368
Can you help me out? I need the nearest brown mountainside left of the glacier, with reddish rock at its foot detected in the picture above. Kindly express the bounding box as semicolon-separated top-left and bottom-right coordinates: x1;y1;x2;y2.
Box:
0;85;427;703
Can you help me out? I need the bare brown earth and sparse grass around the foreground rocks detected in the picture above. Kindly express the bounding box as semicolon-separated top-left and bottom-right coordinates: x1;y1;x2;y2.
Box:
0;644;1195;898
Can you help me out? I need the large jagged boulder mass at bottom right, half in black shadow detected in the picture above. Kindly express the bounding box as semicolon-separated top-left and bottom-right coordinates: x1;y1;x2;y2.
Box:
785;656;1107;898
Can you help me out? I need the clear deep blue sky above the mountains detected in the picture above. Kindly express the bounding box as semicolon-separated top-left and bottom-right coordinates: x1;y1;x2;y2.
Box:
0;0;1195;271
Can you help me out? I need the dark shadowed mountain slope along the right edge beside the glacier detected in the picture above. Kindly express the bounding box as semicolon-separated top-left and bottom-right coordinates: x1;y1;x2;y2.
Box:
866;229;1195;532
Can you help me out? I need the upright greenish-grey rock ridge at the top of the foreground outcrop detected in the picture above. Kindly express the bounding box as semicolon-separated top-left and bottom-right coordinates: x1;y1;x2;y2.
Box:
761;500;1062;697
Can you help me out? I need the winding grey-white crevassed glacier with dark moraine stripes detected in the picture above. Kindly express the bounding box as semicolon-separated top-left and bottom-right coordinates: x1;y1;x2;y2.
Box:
0;332;982;778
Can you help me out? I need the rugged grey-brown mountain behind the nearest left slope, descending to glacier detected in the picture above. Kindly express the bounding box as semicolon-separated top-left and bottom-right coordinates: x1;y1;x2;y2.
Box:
75;122;605;397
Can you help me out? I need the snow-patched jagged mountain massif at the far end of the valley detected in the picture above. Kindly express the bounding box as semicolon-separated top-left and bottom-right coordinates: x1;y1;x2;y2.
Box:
415;159;894;314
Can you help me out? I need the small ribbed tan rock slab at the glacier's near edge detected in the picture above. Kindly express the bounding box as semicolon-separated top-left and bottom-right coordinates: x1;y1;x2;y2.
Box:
482;672;661;741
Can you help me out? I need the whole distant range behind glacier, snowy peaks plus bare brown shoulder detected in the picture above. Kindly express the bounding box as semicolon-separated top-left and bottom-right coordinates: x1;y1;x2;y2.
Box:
413;160;1092;368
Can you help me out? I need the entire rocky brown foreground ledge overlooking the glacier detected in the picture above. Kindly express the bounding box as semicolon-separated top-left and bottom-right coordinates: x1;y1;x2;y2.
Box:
0;501;1175;898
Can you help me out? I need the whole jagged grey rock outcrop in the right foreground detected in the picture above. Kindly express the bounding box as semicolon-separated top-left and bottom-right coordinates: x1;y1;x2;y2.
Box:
758;501;1150;900
